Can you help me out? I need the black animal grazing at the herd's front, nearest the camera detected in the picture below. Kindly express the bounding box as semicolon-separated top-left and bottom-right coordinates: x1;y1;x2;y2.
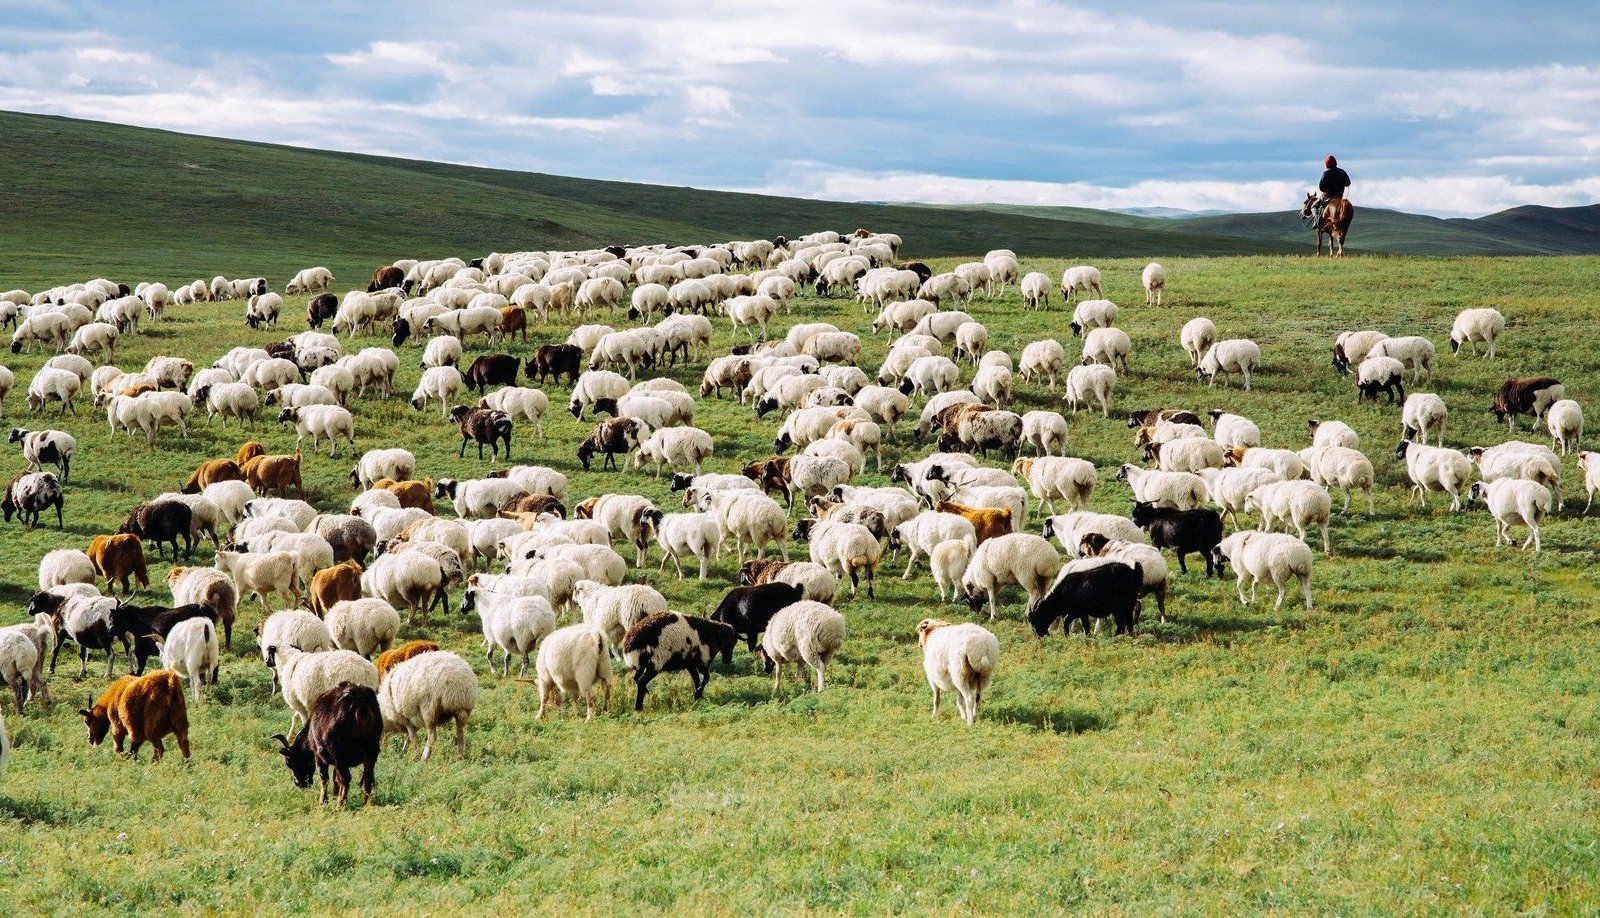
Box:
272;683;384;806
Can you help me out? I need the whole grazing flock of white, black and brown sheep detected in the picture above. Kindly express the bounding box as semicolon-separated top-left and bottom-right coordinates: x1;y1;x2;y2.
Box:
0;230;1580;801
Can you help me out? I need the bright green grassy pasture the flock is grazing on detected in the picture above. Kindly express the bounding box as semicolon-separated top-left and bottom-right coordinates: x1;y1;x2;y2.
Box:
0;252;1600;913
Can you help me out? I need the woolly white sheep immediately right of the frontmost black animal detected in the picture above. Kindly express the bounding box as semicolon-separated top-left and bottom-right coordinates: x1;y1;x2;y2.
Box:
377;651;478;761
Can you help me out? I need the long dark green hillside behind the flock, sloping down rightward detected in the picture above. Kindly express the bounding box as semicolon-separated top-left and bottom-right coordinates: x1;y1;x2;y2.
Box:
0;112;1290;281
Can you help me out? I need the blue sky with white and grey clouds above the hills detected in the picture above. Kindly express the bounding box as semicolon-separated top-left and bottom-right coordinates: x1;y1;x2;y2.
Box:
0;0;1600;216
